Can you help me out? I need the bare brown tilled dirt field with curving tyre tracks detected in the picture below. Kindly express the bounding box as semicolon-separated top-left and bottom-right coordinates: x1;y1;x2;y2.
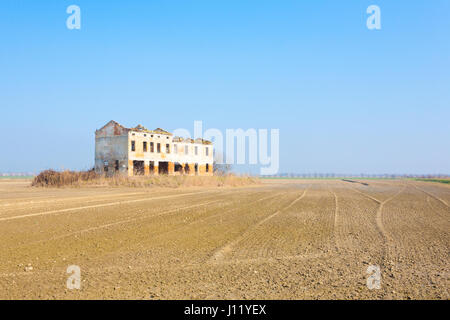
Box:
0;180;450;299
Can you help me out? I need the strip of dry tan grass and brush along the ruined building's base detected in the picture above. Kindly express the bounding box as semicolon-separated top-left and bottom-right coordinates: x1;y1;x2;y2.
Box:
31;170;260;188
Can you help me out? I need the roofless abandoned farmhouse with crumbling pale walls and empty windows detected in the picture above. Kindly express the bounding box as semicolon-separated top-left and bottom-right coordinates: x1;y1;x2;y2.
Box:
95;121;213;176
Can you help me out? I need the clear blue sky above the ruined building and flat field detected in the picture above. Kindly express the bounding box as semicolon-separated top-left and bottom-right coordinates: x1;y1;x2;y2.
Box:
0;0;450;174
